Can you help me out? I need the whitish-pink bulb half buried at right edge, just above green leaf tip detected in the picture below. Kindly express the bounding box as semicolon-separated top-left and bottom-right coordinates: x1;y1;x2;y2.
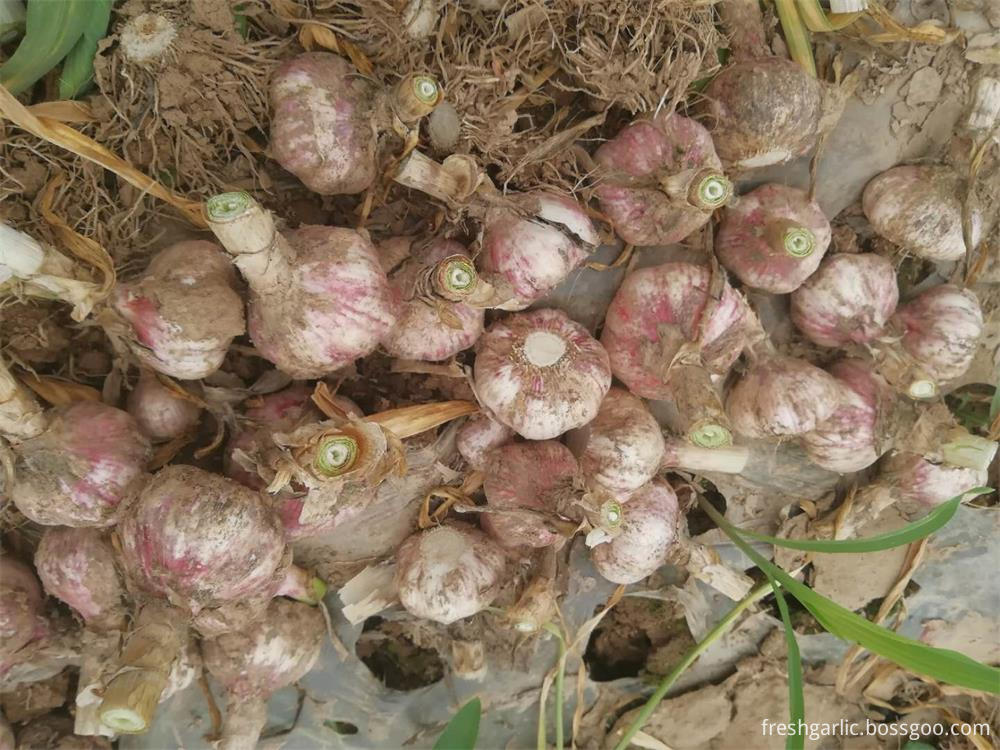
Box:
879;451;989;506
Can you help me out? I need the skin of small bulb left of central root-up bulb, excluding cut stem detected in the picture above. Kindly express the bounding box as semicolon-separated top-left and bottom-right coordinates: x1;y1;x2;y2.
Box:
382;239;485;362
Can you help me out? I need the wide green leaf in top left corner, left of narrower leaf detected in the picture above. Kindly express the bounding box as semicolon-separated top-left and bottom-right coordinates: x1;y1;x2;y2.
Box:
0;0;89;95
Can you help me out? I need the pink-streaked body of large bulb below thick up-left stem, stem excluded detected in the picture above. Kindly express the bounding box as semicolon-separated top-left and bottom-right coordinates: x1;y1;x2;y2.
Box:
247;226;396;379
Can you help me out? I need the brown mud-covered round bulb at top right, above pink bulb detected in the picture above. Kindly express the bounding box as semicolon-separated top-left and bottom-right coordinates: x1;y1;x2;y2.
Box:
700;57;823;169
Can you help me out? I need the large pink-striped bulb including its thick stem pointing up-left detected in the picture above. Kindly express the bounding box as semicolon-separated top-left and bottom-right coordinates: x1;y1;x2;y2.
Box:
205;193;396;379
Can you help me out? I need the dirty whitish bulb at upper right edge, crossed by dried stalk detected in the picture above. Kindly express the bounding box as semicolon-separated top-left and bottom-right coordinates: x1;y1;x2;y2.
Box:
862;166;984;262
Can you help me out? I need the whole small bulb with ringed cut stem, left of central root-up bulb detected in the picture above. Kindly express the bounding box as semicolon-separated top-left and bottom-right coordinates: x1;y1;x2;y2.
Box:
382;239;485;362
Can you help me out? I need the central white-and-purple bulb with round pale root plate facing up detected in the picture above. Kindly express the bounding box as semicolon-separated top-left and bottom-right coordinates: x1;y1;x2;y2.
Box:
474;309;611;440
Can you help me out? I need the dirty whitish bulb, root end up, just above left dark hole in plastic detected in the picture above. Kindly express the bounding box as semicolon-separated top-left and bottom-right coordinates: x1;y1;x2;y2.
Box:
396;523;507;625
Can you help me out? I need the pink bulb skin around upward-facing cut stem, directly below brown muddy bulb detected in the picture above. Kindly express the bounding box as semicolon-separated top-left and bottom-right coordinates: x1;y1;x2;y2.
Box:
715;185;832;294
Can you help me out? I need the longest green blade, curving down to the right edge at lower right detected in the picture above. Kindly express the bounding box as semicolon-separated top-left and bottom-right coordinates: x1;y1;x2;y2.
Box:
698;497;1000;694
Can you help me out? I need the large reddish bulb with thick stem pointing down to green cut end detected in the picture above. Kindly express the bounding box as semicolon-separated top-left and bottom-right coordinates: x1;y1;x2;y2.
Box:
601;263;749;447
